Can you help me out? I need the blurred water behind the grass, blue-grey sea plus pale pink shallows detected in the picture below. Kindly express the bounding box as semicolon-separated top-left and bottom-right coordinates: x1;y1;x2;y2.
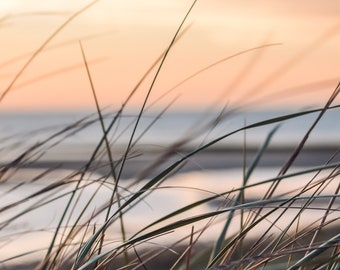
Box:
0;109;340;266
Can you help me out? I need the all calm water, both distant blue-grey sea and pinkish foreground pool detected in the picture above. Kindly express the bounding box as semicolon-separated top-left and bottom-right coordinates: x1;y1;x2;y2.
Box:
0;109;340;267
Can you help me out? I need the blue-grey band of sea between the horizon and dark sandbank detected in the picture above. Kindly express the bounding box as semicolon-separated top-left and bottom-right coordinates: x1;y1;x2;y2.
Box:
0;109;340;150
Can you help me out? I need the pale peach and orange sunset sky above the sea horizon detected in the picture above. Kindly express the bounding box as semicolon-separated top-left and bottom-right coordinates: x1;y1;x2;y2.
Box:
0;0;340;111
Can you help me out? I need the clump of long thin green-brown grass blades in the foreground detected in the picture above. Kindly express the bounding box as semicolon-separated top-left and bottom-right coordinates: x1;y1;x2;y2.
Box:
0;1;340;269
